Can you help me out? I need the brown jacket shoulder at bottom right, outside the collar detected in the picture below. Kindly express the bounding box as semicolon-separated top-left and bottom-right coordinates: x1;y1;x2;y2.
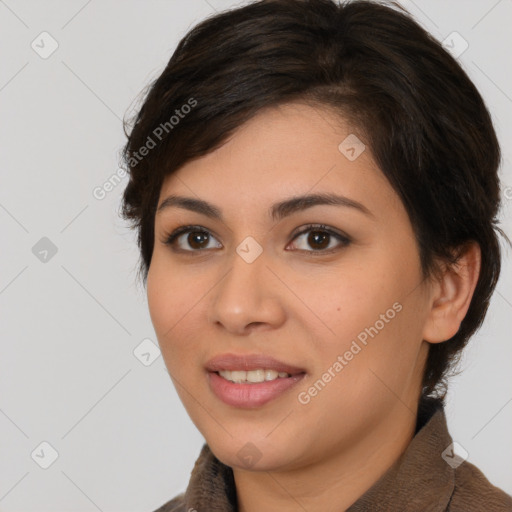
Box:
448;461;512;512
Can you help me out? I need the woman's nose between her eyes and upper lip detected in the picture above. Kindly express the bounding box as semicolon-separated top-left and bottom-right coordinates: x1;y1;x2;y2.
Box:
209;242;285;335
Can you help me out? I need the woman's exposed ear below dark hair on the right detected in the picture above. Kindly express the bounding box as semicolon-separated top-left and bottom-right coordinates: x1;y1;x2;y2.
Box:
423;242;481;343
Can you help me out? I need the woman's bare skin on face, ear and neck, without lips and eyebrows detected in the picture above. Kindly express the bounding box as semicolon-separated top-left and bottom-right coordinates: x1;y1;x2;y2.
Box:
147;103;480;512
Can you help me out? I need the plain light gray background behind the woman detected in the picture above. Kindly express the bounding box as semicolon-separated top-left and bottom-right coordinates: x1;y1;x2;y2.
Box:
0;0;512;512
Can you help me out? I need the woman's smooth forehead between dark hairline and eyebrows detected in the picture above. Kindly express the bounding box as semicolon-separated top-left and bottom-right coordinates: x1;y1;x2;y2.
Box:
159;103;396;218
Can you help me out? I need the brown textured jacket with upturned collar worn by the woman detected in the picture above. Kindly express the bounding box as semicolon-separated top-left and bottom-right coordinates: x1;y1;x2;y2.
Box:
155;399;512;512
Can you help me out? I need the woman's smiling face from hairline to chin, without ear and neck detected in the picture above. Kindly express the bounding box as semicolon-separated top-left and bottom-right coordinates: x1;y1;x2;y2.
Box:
147;103;436;470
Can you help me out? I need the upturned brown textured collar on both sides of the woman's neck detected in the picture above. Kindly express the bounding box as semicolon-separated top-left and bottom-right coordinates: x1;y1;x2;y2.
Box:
184;399;455;512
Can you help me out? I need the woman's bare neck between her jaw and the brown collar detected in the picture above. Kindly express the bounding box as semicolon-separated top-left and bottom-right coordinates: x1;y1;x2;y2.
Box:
233;402;417;512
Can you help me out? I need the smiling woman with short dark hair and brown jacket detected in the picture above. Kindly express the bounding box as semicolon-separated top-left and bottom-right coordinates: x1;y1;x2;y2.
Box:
123;0;512;512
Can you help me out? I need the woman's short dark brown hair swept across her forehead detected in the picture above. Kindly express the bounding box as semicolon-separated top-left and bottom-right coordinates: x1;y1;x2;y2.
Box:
122;0;510;398
